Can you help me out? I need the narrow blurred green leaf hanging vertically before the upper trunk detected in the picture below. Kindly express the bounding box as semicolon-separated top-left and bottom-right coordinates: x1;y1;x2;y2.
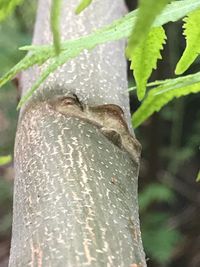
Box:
51;0;61;55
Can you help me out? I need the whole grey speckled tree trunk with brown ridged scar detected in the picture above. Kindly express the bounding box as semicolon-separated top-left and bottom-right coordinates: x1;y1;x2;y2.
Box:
9;0;146;267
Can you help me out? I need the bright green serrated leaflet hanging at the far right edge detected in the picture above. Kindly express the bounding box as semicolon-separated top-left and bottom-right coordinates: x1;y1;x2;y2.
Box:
175;9;200;74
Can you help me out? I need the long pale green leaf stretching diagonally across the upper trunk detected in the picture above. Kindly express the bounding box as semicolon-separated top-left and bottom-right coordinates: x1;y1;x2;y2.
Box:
0;0;200;107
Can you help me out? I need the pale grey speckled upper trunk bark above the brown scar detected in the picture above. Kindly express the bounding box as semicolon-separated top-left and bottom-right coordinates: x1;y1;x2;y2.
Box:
22;0;131;129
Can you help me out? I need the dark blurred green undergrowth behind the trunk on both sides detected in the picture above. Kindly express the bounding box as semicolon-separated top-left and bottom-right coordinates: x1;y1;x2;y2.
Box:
0;0;200;267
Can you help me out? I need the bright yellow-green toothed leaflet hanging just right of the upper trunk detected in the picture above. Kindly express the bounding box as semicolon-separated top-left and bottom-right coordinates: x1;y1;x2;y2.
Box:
129;27;166;100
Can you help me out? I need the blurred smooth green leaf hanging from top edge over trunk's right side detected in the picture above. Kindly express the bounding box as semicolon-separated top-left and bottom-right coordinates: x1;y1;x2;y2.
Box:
126;0;170;55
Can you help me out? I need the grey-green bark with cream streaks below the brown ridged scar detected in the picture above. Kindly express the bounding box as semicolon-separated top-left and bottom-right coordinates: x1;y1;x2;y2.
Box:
10;103;144;267
